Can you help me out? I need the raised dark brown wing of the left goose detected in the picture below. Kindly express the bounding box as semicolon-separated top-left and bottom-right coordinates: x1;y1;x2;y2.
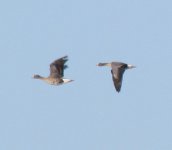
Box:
50;56;68;78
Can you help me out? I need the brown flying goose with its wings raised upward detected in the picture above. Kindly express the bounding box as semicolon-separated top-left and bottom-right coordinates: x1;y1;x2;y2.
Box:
33;56;73;85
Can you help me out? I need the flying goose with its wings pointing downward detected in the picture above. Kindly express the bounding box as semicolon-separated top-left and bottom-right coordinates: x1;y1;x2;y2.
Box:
97;62;135;92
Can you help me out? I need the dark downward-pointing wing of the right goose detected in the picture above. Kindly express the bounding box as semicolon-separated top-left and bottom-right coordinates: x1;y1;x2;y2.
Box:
111;64;126;92
